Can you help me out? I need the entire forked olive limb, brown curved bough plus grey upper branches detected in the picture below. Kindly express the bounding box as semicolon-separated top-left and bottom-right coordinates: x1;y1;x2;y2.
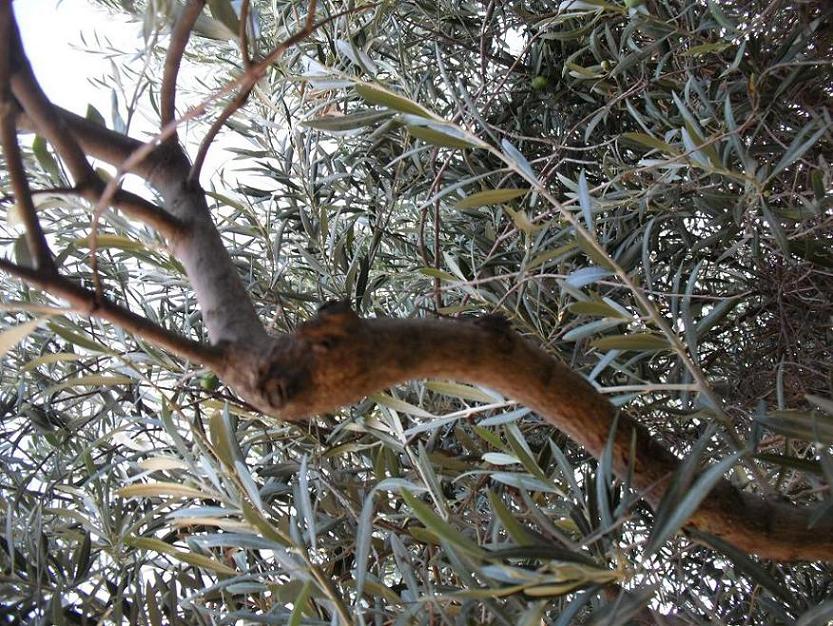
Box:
0;1;833;560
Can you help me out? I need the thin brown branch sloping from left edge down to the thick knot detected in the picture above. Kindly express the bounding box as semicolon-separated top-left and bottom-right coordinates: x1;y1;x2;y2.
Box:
0;258;223;368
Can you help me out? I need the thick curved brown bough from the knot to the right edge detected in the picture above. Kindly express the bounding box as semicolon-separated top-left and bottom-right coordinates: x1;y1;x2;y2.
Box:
218;305;833;561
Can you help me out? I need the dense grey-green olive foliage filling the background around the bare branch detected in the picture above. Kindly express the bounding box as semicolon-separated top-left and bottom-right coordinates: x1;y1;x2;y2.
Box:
0;0;833;625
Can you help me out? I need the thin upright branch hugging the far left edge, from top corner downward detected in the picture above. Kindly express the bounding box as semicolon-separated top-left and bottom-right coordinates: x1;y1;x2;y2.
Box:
0;3;55;273
